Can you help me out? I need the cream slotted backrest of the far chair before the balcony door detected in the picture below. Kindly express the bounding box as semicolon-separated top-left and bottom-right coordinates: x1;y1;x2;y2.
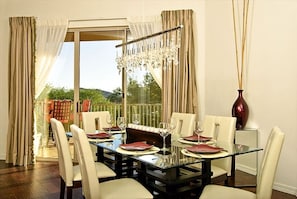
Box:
81;111;109;133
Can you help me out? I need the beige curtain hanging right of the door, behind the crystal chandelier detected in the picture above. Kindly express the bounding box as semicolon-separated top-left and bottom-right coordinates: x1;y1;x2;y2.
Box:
161;10;198;121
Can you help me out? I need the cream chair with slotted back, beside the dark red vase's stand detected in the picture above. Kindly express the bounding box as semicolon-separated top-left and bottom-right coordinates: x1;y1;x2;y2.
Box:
191;115;236;184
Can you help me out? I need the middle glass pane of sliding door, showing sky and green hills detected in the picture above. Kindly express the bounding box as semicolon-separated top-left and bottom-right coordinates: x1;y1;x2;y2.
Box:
80;40;122;121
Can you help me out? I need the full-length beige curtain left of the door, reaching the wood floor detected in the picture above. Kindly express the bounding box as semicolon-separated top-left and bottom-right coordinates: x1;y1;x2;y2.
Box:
6;17;35;166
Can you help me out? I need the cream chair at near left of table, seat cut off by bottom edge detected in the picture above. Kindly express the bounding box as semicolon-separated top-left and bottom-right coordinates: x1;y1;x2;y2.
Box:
70;124;153;199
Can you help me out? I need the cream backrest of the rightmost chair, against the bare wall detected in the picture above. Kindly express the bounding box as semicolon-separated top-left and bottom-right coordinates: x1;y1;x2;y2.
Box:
256;126;285;199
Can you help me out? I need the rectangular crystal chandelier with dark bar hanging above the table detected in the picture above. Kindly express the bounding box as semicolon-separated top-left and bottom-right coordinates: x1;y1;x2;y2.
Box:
116;25;183;72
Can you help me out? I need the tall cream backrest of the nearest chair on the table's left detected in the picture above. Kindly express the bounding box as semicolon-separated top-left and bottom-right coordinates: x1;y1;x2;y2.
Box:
70;124;100;199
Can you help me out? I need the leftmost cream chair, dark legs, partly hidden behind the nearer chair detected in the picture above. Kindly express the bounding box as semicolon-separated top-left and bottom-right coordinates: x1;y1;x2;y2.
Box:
50;118;116;198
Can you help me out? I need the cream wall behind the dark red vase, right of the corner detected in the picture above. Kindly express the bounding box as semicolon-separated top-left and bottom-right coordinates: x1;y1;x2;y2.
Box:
205;0;297;194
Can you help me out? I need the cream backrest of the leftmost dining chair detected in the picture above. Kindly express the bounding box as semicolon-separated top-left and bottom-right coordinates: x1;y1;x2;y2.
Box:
50;118;73;186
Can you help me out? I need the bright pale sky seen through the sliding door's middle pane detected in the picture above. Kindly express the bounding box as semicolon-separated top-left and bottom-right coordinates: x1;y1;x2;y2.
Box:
80;41;122;92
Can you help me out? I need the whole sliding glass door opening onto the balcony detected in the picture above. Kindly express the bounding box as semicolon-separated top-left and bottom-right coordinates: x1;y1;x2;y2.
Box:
35;24;161;157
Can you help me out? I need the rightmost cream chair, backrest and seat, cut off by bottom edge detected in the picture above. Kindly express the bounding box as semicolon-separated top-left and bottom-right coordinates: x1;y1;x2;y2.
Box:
200;127;285;199
